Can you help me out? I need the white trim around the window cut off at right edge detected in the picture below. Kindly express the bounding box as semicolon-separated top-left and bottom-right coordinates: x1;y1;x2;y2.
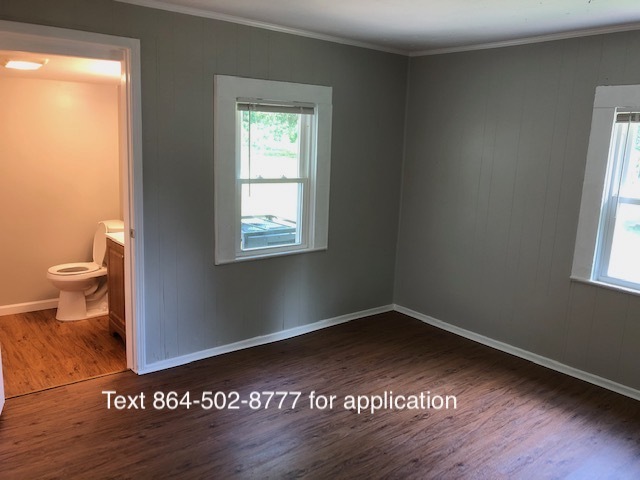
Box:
571;85;640;294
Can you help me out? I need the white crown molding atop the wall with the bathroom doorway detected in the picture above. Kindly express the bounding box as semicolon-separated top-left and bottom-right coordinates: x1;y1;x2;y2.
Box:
115;0;410;56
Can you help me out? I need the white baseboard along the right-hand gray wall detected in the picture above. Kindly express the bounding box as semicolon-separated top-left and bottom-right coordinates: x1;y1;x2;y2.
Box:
393;305;640;400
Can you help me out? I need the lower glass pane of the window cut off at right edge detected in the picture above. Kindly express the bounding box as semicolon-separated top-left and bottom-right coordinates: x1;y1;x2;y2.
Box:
608;204;640;284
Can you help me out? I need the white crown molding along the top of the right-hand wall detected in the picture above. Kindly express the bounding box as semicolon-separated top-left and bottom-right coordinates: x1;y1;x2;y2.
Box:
408;23;640;57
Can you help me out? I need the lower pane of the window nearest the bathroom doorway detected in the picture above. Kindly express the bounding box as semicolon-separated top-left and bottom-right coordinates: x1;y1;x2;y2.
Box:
241;183;302;250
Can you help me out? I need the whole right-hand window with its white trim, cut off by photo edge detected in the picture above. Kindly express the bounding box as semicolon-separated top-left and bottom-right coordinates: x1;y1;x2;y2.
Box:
572;86;640;292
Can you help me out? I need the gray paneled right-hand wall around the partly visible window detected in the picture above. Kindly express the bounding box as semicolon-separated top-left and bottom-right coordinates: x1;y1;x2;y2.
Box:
395;32;640;388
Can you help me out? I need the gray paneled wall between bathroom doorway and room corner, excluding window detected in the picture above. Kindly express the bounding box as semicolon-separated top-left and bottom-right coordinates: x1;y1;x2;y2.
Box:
0;0;408;363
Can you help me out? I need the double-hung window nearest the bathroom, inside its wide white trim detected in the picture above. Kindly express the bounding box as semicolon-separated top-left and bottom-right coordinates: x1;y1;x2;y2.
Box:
236;102;314;249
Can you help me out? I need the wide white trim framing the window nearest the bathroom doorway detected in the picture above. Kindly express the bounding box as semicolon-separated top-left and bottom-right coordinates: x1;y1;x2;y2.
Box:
213;75;332;265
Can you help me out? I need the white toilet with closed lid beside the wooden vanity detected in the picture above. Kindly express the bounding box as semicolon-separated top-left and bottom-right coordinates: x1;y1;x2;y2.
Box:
47;220;124;321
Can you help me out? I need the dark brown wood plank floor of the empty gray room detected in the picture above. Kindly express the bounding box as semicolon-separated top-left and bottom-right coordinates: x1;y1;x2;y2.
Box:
0;313;640;479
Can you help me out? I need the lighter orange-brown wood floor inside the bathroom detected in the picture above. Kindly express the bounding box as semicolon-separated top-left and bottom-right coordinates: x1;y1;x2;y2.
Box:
0;309;127;398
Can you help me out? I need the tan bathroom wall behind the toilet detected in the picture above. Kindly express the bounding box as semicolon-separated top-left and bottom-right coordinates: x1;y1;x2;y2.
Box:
0;77;121;308
